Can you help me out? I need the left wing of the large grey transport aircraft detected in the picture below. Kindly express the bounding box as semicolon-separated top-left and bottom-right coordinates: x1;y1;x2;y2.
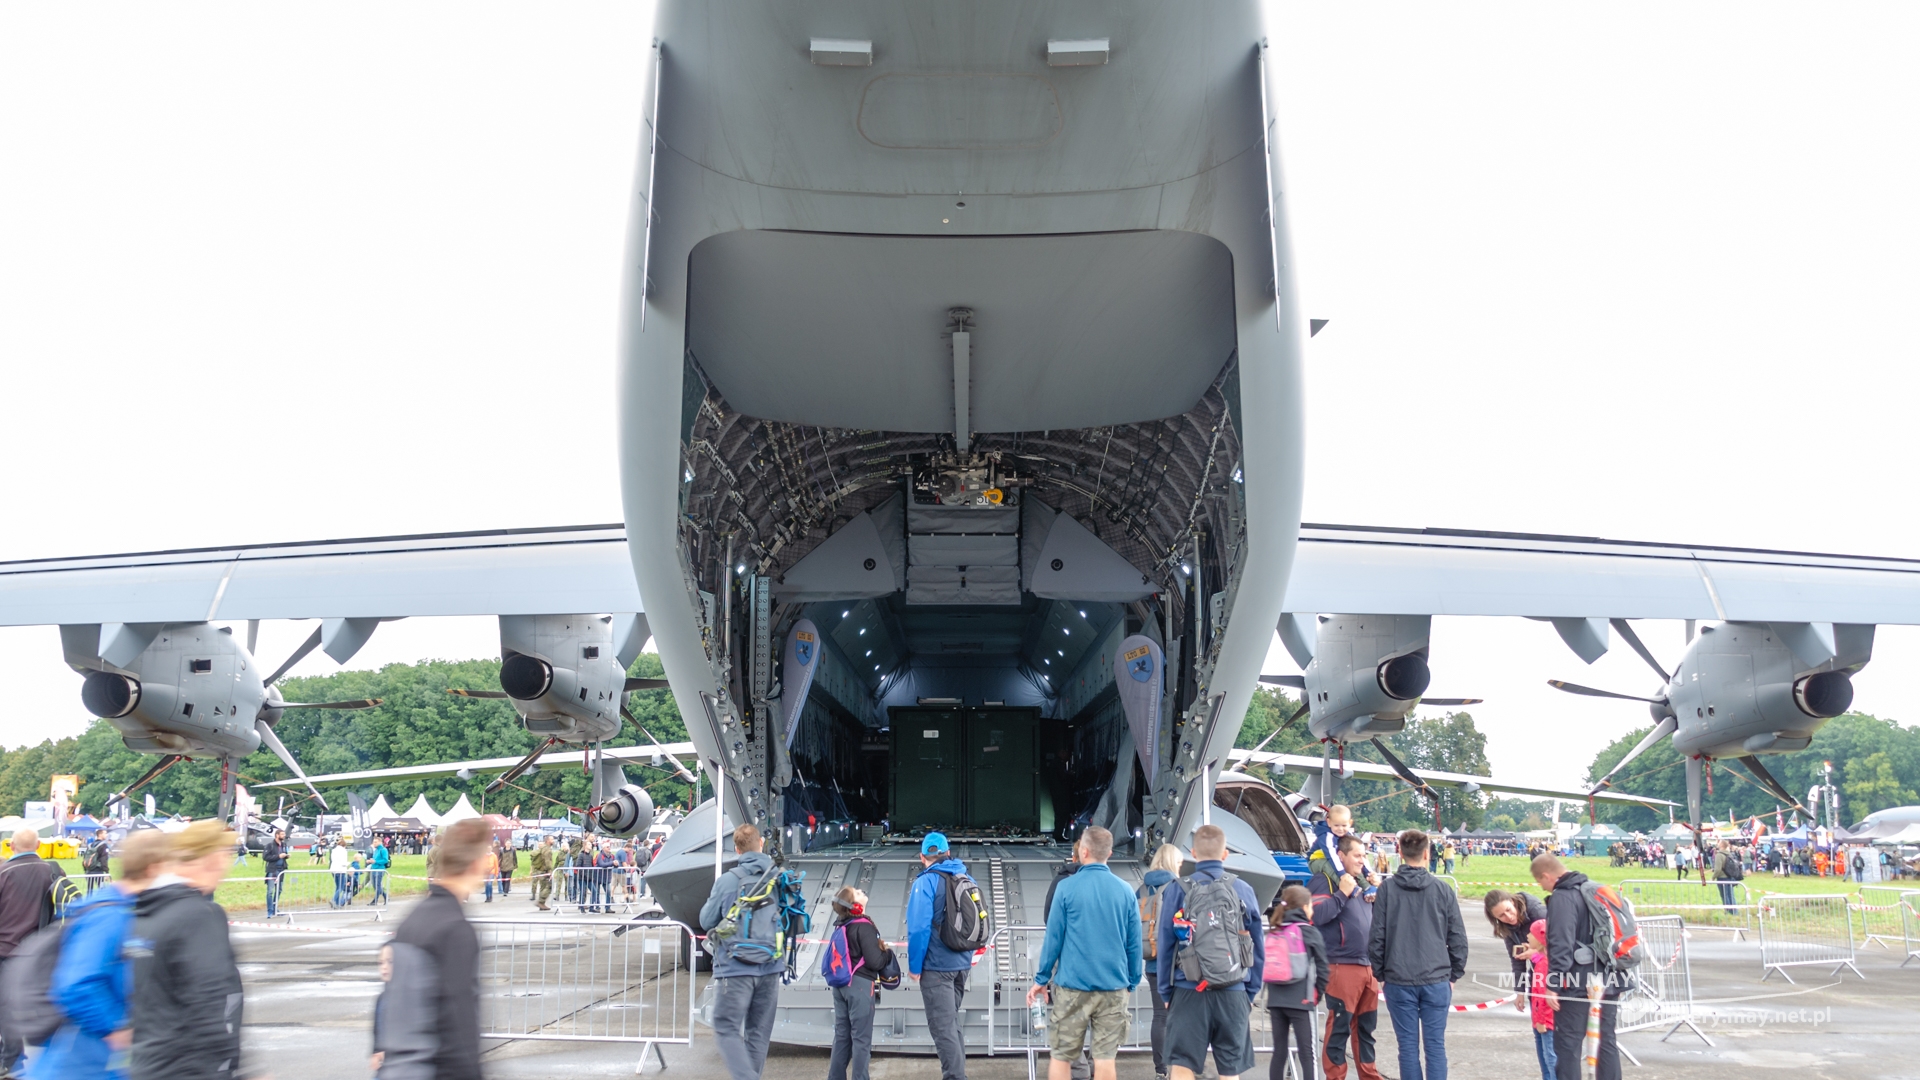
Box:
0;525;641;626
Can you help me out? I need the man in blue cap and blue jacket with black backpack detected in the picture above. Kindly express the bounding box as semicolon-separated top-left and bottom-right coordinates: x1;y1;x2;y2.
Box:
906;832;989;1080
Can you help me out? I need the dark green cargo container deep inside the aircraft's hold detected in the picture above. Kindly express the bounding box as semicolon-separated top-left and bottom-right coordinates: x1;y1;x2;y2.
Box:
889;707;1041;834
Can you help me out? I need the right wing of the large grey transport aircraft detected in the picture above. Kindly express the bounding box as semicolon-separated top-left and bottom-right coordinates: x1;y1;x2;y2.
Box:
1286;525;1920;625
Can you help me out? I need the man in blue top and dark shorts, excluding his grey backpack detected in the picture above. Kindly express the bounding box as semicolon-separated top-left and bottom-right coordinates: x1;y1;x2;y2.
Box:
1154;824;1267;1080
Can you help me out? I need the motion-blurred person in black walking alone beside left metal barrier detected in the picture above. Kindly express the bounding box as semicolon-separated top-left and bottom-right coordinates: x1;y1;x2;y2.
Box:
374;817;493;1080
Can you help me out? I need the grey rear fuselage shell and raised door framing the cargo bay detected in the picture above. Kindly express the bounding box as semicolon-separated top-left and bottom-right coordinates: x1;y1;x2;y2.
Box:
620;2;1306;834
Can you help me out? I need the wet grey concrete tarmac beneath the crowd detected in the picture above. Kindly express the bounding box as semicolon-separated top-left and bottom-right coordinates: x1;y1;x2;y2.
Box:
232;896;1920;1080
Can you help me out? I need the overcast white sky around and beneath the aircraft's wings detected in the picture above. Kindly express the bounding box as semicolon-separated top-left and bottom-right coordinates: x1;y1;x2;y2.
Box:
0;4;1920;784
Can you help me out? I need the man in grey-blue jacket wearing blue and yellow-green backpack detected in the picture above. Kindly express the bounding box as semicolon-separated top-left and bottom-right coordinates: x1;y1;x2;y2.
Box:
701;824;787;1080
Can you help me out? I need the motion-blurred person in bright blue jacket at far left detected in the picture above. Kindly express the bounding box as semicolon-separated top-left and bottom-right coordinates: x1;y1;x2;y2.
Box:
27;830;167;1080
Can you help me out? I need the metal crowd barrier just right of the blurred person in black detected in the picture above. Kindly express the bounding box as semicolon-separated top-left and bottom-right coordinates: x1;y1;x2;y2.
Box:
474;919;695;1072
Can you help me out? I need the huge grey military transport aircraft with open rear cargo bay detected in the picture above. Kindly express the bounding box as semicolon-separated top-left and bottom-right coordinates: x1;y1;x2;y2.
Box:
0;0;1920;1049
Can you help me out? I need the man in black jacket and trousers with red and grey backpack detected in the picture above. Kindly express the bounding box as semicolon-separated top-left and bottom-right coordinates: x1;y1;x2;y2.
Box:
1532;855;1638;1080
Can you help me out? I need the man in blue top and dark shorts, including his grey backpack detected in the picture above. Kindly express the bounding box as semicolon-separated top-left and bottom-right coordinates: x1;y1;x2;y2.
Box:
1154;824;1265;1080
